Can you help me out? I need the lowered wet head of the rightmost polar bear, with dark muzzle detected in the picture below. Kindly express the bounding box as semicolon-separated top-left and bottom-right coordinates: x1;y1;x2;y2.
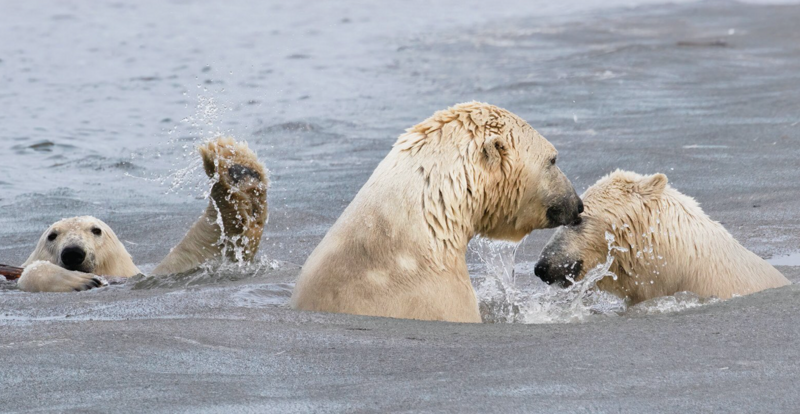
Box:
534;170;672;287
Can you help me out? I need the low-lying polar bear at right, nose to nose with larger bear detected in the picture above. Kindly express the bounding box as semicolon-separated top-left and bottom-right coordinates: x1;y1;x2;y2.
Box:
534;170;789;305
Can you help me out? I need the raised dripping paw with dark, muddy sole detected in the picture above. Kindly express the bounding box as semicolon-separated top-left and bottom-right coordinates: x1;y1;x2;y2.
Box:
199;137;269;260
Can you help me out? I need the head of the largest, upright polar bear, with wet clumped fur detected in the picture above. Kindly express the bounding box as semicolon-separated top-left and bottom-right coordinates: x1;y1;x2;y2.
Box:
392;102;583;243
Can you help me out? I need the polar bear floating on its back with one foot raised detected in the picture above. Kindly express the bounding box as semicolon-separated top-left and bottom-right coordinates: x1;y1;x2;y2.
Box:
18;138;269;292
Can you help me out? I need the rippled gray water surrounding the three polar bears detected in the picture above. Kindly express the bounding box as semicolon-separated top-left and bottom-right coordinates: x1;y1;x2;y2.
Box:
0;1;800;412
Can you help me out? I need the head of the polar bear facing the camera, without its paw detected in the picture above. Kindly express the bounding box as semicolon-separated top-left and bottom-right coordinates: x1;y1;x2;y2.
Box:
23;216;140;277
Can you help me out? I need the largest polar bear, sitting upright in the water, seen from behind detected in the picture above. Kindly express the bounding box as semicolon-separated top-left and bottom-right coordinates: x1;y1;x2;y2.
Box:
291;102;583;322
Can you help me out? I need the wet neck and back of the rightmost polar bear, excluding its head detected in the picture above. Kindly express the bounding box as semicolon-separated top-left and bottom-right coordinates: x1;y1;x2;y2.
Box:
611;188;785;303
